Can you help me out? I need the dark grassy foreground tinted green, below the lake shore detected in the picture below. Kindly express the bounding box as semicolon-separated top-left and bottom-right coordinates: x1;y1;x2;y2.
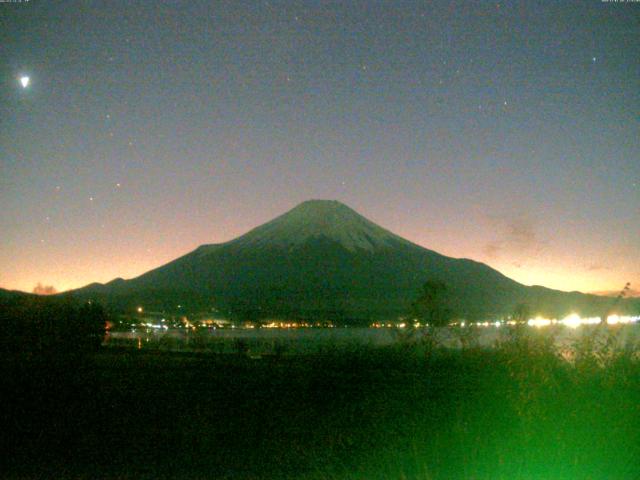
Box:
0;339;640;480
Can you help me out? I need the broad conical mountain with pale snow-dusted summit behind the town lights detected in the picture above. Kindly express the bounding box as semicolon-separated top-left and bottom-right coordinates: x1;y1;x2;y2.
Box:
74;200;630;322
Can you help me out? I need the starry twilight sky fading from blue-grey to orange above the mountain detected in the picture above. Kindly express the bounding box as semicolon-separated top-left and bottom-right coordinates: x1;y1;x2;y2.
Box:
0;0;640;291
